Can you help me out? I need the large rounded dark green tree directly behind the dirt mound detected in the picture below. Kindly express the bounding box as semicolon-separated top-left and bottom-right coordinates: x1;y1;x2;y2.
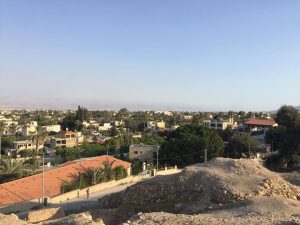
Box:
159;125;223;167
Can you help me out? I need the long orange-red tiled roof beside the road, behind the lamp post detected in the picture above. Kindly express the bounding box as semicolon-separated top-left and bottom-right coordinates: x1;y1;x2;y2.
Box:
0;156;131;206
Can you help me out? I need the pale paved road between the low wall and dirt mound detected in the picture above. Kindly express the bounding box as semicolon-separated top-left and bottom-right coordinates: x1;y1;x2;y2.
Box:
51;182;137;210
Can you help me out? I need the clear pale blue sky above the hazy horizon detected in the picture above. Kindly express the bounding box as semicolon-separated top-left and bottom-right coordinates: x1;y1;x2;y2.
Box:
0;0;300;111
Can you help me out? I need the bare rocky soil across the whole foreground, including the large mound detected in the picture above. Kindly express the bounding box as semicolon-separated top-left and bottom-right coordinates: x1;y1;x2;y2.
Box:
0;158;300;225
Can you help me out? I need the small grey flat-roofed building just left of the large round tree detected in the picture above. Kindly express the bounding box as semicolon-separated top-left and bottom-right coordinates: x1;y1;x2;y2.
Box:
129;144;159;163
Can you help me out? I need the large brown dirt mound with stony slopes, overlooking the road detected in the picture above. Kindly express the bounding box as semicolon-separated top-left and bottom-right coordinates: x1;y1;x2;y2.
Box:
99;158;300;214
